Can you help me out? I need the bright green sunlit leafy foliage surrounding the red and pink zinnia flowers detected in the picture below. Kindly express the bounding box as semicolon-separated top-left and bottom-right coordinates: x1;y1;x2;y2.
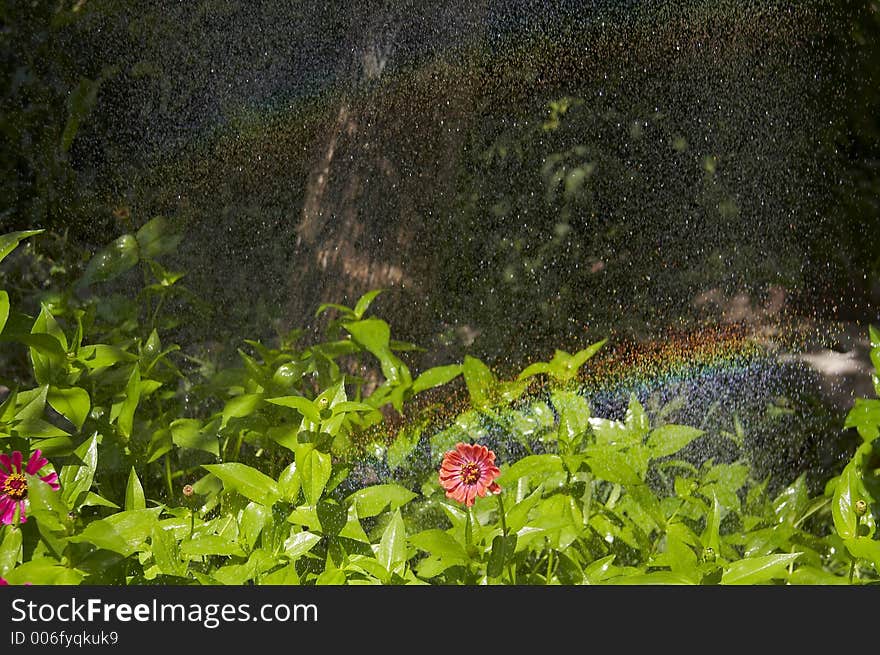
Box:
0;229;880;585
